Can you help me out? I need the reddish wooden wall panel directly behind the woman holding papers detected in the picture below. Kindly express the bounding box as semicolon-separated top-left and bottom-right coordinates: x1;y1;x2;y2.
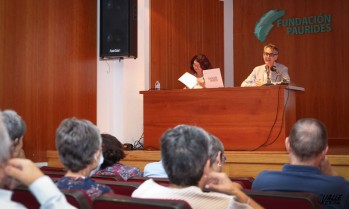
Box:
150;0;224;89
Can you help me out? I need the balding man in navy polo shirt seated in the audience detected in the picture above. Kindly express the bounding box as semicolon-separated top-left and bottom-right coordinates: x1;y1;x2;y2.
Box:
252;118;349;209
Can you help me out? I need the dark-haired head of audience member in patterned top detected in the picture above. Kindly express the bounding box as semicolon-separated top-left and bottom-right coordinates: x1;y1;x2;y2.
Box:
101;134;126;169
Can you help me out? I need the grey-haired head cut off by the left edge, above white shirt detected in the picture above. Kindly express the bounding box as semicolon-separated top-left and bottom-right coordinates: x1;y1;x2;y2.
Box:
0;112;12;172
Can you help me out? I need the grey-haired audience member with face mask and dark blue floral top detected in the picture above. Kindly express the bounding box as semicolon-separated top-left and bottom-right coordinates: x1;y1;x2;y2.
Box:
56;118;113;200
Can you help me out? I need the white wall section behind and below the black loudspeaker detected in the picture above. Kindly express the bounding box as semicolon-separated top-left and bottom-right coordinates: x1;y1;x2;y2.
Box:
97;0;150;144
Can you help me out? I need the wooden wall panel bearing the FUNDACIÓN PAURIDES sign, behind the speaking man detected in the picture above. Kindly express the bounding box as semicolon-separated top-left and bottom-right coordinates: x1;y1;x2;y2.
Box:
231;0;349;152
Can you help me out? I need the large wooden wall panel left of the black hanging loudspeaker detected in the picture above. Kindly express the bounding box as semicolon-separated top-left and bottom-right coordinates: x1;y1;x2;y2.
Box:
0;0;97;161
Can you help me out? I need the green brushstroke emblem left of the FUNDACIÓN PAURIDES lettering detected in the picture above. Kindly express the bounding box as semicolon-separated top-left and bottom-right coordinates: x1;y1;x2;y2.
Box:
254;10;285;42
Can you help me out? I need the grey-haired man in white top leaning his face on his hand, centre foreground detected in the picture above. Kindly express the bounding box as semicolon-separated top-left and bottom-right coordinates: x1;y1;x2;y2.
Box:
132;125;262;209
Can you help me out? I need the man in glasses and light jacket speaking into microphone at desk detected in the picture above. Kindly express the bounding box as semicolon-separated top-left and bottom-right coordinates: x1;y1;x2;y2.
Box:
241;44;290;87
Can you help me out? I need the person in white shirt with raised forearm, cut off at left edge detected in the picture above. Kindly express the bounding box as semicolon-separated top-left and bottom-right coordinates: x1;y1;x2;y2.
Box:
0;112;75;209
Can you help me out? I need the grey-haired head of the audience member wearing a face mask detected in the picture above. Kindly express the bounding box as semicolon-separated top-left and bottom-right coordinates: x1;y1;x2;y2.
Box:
56;118;102;174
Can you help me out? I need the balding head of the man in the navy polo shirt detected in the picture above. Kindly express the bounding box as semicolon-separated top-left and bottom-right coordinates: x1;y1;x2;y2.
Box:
286;118;328;162
